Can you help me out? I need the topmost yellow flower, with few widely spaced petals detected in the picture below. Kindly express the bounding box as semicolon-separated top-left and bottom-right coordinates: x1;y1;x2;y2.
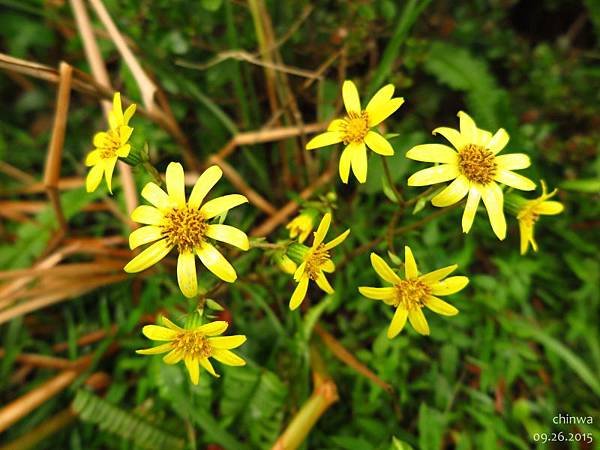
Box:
306;80;404;183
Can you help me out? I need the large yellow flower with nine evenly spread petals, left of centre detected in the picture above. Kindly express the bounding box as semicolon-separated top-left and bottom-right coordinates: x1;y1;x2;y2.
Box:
124;162;250;297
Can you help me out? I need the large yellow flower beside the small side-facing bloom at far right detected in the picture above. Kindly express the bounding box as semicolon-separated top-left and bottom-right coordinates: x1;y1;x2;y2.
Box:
406;111;535;240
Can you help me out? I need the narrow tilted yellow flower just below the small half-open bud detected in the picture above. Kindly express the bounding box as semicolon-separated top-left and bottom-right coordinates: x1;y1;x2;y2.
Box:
290;213;350;310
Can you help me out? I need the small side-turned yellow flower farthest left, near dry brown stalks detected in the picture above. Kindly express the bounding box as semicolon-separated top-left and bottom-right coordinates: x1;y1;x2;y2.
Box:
85;92;136;193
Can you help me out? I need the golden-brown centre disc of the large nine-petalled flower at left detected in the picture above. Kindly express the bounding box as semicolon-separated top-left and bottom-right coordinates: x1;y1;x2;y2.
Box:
162;207;208;253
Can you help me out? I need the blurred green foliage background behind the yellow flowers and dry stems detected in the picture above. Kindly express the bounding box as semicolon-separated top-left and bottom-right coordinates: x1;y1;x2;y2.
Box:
0;0;600;450
